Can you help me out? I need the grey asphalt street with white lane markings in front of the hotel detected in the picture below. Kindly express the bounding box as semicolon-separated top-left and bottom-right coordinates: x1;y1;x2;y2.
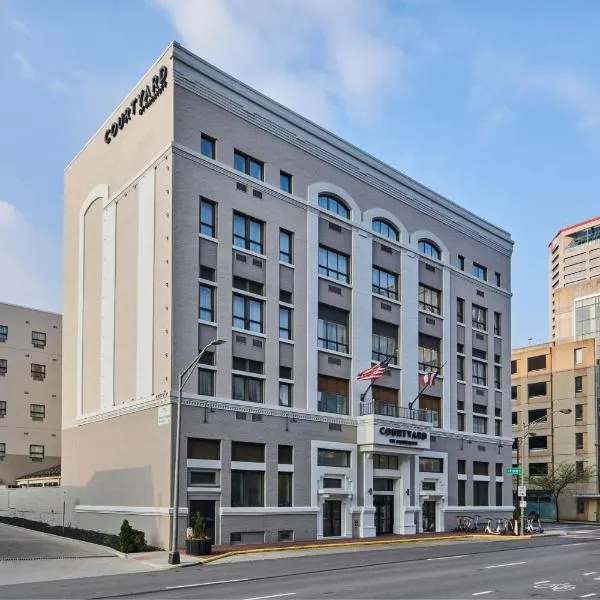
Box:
0;527;600;600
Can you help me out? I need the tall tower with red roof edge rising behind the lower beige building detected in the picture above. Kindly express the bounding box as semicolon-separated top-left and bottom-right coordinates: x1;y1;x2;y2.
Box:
548;217;600;356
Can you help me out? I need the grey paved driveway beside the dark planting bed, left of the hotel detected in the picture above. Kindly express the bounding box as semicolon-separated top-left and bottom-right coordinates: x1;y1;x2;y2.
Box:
0;523;114;560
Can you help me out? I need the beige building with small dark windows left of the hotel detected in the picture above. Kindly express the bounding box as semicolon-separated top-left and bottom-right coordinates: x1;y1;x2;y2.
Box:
0;304;62;485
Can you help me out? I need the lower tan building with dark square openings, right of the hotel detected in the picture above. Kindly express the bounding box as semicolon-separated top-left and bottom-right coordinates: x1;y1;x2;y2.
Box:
511;338;600;521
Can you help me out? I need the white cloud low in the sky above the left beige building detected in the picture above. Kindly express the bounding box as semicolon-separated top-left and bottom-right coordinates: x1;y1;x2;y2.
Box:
0;200;62;311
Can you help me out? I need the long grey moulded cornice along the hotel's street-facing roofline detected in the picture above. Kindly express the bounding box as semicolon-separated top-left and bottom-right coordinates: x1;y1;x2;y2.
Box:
174;57;513;256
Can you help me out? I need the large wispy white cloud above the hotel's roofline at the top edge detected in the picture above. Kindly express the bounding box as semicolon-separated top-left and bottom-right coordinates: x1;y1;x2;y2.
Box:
154;0;408;123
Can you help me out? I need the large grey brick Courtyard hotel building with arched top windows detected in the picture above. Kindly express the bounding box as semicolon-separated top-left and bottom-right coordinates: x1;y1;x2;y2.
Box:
62;44;512;547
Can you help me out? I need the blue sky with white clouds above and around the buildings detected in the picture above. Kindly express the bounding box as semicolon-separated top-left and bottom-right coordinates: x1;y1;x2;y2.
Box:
0;0;600;346
